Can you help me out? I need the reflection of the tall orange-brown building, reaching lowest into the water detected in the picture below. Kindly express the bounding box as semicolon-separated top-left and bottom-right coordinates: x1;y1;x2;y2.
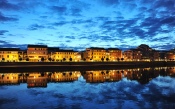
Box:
27;73;47;88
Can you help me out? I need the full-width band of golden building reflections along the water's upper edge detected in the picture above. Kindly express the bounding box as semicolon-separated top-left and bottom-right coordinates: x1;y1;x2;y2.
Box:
0;67;175;88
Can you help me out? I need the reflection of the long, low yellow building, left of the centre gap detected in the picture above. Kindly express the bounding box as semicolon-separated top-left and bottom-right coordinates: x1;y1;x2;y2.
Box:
51;71;81;82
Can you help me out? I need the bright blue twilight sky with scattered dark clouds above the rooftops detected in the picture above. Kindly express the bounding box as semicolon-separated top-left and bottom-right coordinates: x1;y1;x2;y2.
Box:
0;0;175;50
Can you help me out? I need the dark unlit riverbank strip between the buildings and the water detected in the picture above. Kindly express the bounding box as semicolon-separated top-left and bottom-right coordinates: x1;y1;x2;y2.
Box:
0;61;175;72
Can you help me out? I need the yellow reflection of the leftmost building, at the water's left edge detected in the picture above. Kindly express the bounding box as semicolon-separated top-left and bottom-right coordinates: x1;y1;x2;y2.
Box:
0;73;19;85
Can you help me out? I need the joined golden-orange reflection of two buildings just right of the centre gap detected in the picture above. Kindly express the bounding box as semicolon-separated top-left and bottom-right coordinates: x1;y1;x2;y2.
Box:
83;70;122;83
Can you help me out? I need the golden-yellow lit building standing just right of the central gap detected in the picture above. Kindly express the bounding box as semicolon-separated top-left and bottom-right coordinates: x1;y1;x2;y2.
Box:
84;47;106;61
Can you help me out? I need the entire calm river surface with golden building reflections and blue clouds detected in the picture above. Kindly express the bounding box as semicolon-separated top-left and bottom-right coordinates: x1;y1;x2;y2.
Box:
0;67;175;109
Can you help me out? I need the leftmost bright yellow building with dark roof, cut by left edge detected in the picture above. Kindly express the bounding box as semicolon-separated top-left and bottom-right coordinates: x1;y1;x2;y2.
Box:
0;48;19;62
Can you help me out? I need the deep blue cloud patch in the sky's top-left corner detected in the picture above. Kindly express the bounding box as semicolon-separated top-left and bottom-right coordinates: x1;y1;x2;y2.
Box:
0;0;20;10
